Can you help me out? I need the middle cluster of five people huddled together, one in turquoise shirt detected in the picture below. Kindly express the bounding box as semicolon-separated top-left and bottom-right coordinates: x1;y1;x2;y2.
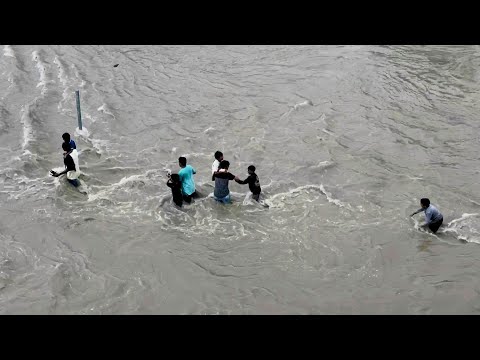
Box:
167;151;262;207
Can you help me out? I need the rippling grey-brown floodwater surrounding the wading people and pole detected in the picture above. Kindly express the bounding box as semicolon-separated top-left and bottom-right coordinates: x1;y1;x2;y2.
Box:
0;45;480;314
